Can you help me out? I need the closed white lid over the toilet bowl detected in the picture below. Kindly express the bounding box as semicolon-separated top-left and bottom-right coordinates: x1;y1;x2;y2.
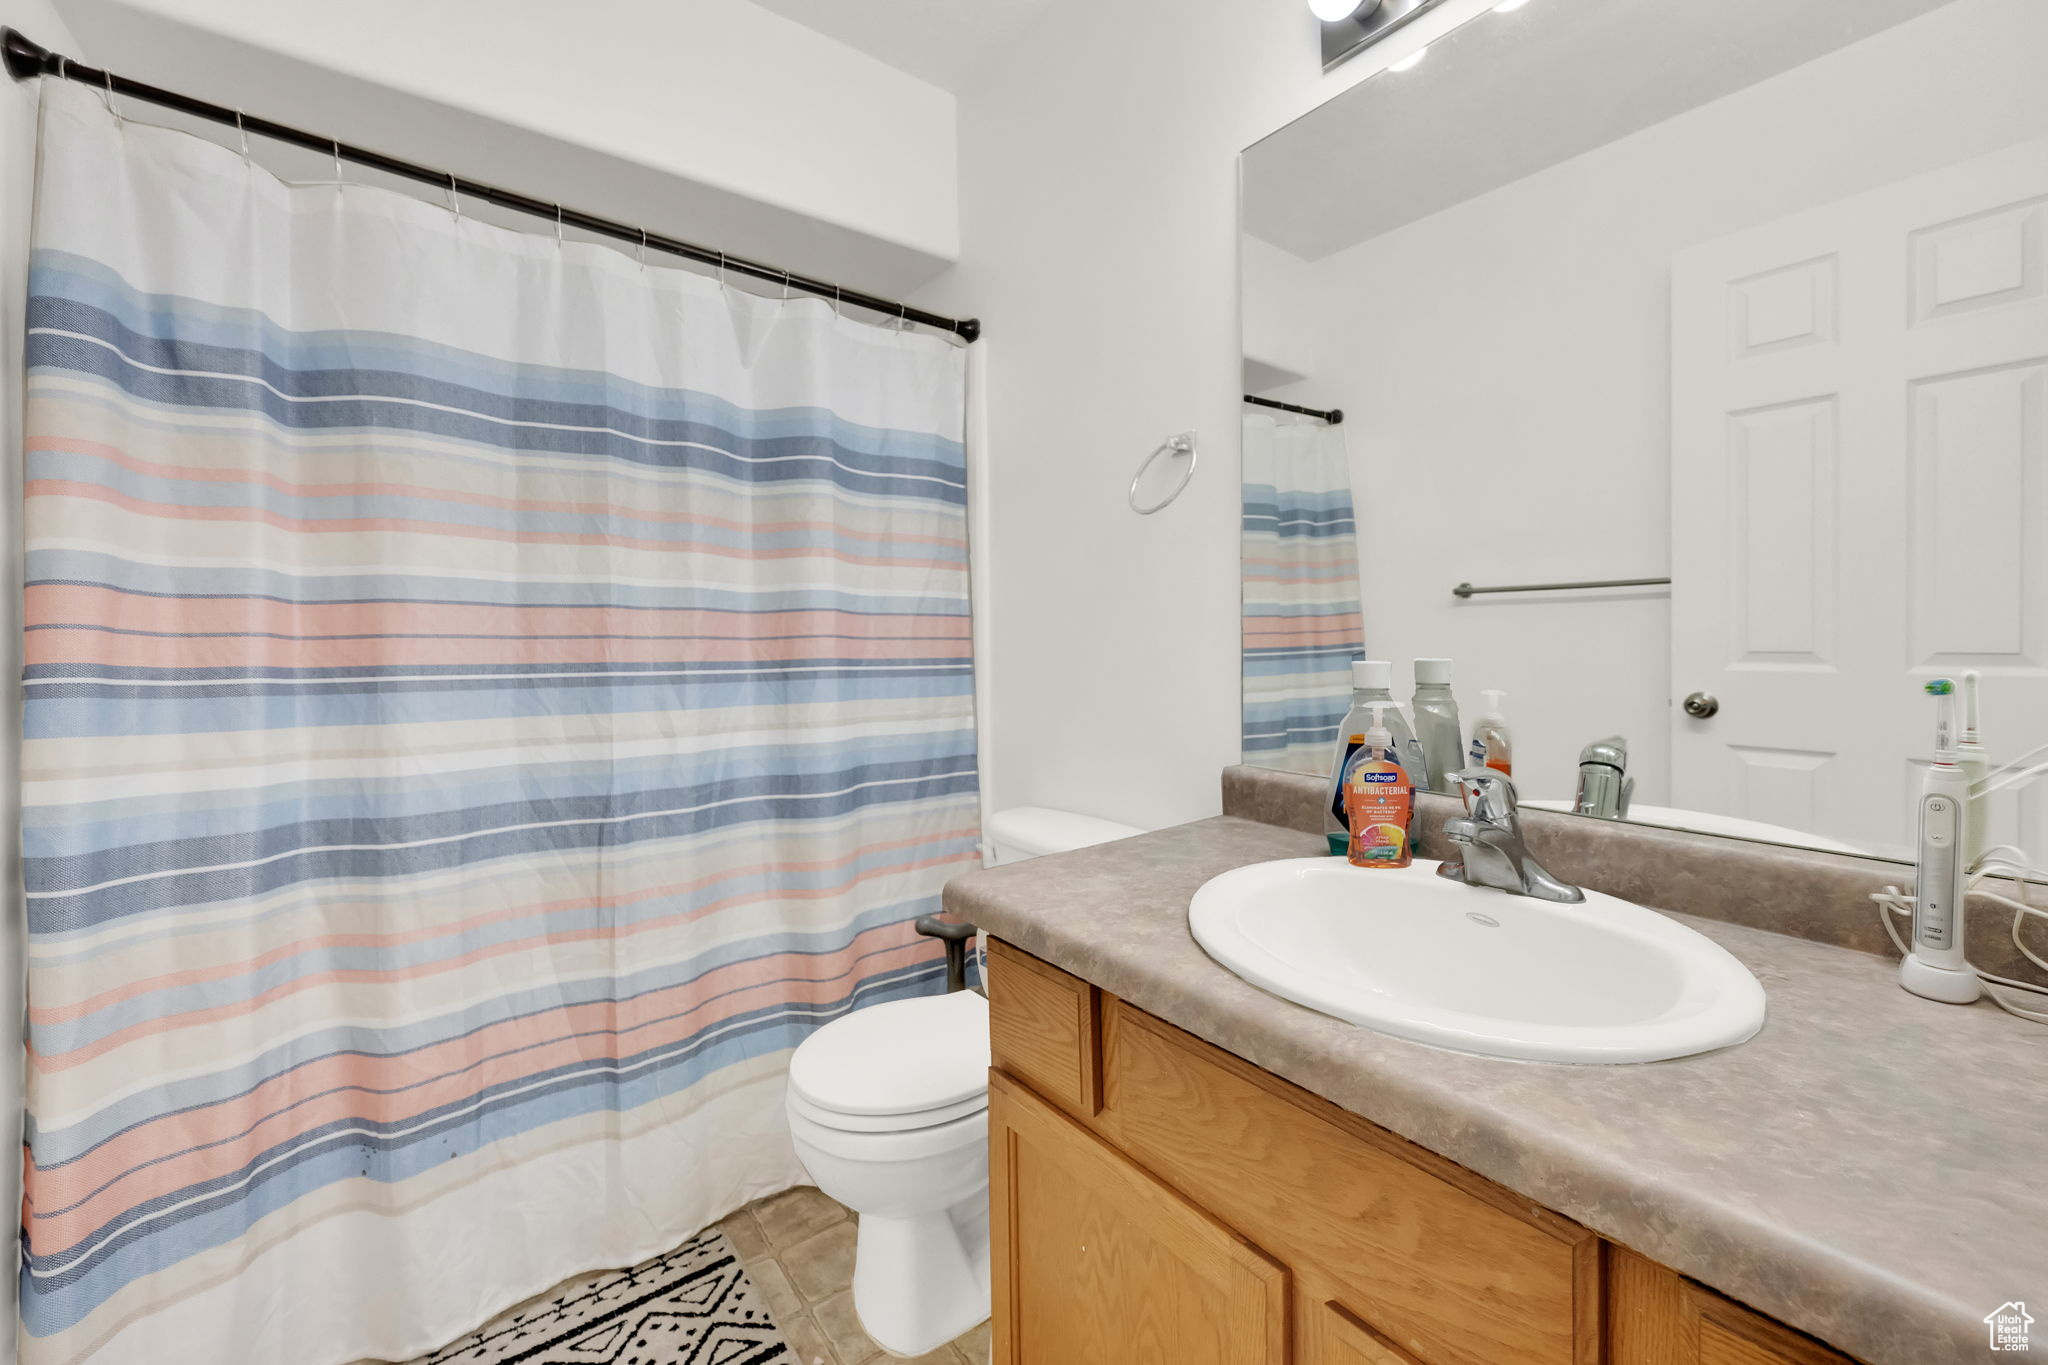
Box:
788;990;989;1115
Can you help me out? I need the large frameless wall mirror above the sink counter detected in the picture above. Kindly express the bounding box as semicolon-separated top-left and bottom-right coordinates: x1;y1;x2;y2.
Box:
1241;0;2048;857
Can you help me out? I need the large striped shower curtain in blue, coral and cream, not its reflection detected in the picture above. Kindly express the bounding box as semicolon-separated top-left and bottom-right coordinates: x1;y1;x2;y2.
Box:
20;82;979;1365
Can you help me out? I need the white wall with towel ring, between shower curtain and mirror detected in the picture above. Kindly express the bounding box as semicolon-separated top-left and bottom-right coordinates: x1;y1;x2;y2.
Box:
924;0;1489;825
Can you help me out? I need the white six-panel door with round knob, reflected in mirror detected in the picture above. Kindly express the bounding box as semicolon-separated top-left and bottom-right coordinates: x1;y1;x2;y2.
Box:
1671;141;2048;853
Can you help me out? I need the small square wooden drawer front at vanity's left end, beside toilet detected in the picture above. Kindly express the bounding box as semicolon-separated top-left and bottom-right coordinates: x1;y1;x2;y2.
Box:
989;939;1102;1117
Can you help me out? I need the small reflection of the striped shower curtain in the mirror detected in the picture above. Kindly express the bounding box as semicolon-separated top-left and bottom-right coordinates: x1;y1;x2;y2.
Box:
1243;413;1364;774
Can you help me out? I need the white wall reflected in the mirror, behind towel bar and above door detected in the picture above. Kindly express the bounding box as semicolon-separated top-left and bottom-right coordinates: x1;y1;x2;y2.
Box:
1247;0;2048;804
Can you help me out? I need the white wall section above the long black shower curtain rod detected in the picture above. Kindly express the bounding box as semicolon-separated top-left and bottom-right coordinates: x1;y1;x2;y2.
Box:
51;0;958;297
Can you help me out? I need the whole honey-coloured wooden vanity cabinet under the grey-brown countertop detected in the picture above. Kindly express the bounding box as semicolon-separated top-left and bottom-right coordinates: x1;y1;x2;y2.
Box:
989;941;1849;1365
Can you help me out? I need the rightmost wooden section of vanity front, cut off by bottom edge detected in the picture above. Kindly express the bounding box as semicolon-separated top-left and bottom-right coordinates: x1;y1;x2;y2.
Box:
1608;1246;1851;1365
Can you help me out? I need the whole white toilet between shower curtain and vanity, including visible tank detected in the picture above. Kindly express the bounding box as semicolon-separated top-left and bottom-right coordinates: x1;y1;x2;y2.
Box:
788;806;1145;1355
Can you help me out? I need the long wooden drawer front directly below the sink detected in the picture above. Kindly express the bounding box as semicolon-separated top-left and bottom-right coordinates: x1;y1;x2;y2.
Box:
1102;997;1597;1365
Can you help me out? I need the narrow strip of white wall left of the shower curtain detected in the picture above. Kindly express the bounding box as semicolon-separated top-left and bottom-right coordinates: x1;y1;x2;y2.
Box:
0;21;74;1365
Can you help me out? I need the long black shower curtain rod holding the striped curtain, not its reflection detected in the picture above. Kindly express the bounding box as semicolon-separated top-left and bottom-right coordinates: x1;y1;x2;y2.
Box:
0;29;981;342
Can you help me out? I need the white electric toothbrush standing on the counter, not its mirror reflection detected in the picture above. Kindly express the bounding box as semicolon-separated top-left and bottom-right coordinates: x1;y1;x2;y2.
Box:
1898;677;1985;1005
